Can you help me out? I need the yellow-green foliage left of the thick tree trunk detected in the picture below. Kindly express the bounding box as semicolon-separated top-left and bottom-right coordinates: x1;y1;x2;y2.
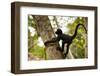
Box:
28;15;45;59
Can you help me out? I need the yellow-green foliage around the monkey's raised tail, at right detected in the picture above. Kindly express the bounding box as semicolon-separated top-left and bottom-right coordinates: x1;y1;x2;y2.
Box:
67;17;87;58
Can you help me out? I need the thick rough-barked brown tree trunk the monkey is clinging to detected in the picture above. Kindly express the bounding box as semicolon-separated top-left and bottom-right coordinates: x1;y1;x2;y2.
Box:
33;15;63;60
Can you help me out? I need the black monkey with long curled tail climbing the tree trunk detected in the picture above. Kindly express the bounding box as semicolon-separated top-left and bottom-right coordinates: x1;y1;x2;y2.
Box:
44;24;87;57
